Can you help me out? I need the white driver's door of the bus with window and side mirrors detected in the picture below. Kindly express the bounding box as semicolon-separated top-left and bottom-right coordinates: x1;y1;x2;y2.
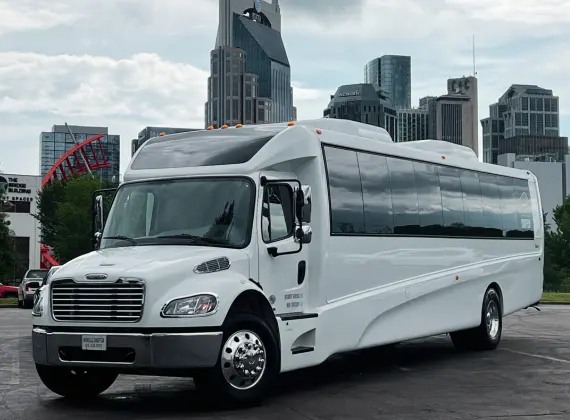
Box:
258;176;312;316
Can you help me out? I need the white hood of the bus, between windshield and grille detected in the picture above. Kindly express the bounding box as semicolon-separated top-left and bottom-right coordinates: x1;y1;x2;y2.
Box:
54;245;250;282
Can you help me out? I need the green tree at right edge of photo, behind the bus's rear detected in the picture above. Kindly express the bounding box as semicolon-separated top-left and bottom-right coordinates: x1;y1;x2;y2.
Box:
544;196;570;291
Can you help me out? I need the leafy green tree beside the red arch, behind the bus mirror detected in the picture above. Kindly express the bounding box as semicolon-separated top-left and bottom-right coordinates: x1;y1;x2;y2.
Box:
33;174;116;264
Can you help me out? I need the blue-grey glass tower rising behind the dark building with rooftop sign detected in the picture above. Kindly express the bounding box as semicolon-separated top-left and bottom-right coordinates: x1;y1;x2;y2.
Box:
364;55;412;109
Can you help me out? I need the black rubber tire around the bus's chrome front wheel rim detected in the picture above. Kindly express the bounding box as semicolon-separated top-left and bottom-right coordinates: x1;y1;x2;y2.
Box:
193;314;279;405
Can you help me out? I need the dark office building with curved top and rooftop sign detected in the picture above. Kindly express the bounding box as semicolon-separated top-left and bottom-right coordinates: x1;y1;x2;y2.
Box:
323;83;398;141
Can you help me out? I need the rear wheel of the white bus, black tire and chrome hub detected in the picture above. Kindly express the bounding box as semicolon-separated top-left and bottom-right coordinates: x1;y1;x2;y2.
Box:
449;287;503;351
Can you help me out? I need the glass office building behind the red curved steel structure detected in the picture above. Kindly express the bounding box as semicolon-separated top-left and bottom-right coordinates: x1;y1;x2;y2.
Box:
40;125;121;183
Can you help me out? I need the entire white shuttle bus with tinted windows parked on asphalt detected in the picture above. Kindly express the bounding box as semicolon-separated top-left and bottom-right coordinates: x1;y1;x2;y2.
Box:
33;119;544;402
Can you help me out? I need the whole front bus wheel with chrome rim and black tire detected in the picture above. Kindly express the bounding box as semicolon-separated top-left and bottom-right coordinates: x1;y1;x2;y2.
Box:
193;314;279;404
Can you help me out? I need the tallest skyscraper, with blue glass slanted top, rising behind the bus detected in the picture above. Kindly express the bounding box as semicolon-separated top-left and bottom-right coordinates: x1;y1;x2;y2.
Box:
205;0;293;126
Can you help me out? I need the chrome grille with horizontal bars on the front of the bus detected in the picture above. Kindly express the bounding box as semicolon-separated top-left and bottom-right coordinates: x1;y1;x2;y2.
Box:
51;279;144;322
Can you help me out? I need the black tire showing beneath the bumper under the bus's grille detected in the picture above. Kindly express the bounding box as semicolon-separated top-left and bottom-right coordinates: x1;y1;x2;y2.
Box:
36;364;118;399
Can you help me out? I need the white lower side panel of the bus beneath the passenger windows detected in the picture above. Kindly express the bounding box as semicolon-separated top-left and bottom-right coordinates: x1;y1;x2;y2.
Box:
312;237;542;356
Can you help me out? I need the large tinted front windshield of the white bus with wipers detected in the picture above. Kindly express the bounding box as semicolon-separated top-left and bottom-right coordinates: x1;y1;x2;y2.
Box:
100;177;255;249
